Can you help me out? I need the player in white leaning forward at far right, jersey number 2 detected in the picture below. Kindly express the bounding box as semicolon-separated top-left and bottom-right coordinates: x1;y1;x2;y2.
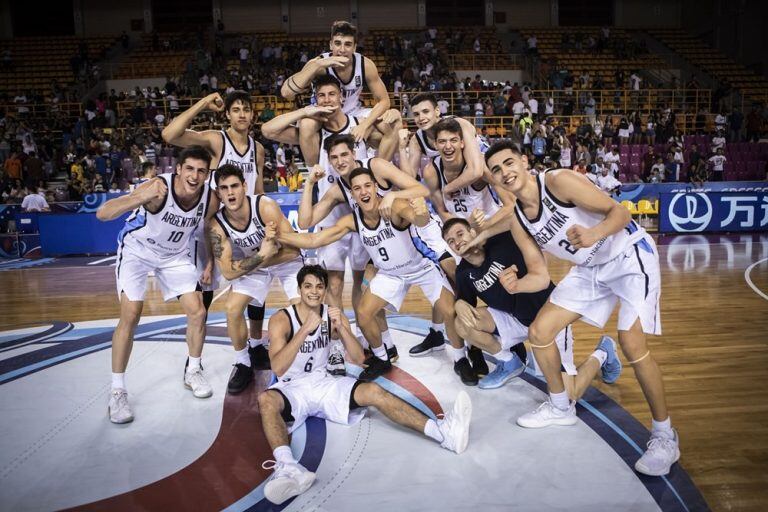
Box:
485;141;680;476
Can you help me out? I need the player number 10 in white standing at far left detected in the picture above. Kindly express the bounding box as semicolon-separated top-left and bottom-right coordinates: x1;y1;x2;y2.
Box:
96;146;218;423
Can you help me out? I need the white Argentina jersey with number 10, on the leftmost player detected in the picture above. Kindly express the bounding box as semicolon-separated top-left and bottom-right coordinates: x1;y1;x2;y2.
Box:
117;173;211;258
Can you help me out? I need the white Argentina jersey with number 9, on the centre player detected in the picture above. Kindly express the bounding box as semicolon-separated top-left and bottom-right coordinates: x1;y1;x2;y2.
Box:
354;209;432;275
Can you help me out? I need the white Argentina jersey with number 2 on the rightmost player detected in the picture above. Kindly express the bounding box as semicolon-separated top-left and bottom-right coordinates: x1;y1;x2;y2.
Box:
515;173;646;267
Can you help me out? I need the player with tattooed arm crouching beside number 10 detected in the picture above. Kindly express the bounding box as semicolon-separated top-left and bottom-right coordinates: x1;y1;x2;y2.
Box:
207;164;303;394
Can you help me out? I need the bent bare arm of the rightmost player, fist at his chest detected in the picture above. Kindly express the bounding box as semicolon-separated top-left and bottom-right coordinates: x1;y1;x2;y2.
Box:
546;170;632;249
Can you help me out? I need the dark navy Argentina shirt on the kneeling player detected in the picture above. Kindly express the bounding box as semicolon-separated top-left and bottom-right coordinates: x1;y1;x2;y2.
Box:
456;231;555;326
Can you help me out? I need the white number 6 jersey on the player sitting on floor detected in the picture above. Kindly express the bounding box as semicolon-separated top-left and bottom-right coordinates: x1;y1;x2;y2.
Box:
280;304;331;382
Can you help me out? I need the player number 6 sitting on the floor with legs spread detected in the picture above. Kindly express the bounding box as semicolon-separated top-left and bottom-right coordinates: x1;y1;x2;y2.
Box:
259;265;472;504
